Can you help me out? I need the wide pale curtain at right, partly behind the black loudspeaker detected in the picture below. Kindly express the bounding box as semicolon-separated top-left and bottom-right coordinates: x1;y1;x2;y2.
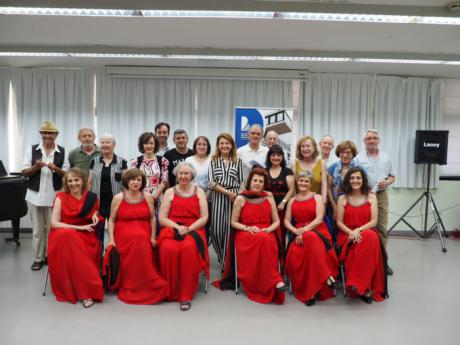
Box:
298;73;442;188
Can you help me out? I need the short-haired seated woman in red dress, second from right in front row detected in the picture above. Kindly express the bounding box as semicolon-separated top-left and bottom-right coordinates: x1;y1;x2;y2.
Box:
284;171;338;307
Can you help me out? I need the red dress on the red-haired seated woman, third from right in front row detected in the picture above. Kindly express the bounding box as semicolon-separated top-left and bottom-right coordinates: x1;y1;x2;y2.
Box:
235;198;285;304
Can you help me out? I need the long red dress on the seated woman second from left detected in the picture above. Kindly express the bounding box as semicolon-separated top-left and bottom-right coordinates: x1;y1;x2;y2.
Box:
114;198;169;304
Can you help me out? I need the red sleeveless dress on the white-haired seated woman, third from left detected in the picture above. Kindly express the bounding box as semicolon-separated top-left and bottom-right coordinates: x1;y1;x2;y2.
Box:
158;188;209;302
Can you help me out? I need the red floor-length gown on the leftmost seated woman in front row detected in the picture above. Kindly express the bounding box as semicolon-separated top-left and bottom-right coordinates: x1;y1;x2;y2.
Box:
48;191;104;303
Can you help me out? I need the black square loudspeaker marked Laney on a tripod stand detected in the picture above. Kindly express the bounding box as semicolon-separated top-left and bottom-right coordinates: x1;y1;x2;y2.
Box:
414;130;449;165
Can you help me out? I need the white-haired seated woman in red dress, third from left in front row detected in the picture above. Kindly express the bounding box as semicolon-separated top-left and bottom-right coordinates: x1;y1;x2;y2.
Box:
158;162;209;311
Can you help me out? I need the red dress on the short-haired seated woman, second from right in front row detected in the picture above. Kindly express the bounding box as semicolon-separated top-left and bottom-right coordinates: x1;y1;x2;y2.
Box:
286;196;339;302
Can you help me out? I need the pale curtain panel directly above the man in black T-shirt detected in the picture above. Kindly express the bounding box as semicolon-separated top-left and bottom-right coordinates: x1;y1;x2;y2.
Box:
97;72;195;159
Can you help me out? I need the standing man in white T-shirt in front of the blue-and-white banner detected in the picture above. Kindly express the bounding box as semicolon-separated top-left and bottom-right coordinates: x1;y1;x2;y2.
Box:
237;124;268;181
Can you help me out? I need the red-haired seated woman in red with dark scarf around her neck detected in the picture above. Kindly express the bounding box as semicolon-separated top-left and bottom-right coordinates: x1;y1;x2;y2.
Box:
214;167;286;304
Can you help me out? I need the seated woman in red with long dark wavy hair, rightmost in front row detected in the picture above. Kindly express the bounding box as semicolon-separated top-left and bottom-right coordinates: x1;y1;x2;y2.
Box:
337;167;388;303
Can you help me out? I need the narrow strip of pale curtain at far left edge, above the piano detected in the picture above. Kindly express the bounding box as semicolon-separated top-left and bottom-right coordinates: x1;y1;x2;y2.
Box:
0;68;10;171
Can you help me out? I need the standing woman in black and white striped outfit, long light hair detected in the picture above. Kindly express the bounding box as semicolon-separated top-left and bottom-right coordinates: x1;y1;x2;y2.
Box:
209;133;243;268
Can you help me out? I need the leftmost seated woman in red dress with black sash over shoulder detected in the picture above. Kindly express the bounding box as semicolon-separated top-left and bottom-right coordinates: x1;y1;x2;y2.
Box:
48;168;104;308
